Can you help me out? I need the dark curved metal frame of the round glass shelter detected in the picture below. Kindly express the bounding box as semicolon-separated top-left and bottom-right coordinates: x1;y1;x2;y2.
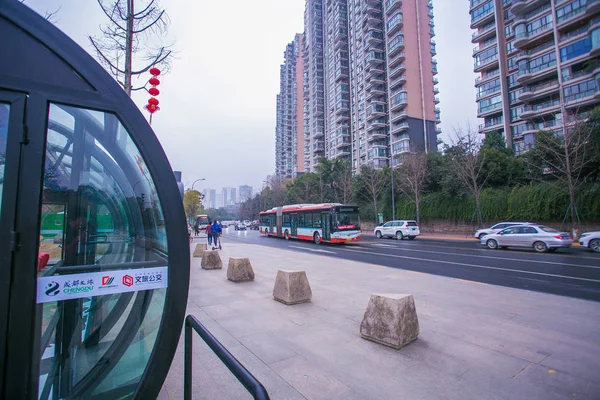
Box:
0;0;189;399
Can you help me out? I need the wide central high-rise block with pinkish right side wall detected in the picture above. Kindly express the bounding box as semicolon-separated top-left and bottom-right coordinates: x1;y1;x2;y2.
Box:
296;0;440;170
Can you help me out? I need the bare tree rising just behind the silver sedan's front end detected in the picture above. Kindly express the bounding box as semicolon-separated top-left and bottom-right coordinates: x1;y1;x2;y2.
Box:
445;125;492;227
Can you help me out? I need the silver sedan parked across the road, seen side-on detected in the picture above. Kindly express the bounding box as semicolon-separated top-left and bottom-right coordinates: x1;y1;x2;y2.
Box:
481;224;573;253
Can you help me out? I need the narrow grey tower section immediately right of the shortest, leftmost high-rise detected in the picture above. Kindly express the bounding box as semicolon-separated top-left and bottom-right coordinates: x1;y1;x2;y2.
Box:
303;0;325;172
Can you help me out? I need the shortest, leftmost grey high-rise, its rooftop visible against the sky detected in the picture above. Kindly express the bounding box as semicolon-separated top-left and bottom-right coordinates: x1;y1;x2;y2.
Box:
275;34;304;178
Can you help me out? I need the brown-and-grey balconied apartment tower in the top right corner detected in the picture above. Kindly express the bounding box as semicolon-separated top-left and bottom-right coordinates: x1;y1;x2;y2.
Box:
470;0;600;154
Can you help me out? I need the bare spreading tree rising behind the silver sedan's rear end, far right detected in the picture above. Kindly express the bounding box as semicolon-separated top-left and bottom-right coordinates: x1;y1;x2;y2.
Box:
525;116;599;238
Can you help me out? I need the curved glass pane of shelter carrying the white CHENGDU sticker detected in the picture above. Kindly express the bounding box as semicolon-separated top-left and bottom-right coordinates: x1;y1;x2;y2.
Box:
36;104;167;399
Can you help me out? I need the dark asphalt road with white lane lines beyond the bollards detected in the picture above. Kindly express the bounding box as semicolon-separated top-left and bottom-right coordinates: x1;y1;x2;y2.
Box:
196;227;600;301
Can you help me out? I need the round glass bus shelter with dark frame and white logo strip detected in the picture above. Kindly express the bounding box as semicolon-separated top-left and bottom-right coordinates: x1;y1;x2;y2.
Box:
0;0;189;400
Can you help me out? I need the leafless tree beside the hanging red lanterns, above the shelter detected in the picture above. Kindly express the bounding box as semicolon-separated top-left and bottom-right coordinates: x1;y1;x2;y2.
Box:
88;0;173;96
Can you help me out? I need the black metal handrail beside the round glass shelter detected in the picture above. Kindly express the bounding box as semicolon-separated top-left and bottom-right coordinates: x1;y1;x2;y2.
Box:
183;315;269;400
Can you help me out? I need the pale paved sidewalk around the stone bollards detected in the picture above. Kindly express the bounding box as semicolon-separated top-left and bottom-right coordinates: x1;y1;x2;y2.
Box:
159;239;600;400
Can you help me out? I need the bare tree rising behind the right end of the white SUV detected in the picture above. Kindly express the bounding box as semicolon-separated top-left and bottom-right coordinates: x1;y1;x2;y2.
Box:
394;153;427;225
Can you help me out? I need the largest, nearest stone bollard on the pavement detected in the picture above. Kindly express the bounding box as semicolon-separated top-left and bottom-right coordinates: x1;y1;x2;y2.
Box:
360;294;419;349
